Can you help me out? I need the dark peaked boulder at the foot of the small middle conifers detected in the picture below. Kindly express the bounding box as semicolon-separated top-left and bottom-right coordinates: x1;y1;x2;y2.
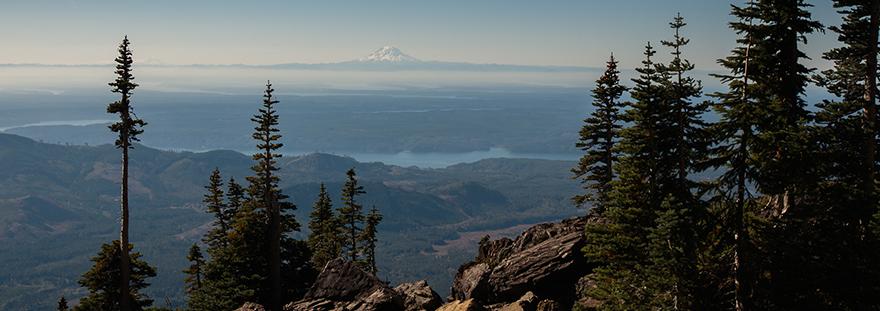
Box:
284;259;405;311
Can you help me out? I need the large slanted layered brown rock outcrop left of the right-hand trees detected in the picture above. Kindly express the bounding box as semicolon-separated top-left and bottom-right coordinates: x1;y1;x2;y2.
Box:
450;217;594;310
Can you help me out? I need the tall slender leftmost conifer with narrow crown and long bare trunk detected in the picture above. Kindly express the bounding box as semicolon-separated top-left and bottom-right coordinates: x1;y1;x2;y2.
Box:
107;36;147;311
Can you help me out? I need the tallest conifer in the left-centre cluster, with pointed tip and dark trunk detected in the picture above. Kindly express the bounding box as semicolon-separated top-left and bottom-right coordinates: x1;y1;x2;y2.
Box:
247;83;299;311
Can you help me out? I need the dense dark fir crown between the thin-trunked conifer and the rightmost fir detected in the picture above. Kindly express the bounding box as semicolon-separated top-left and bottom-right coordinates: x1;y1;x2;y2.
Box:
750;0;822;214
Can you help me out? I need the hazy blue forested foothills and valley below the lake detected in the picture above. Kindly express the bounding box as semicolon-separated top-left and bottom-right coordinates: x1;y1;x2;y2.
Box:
0;133;582;310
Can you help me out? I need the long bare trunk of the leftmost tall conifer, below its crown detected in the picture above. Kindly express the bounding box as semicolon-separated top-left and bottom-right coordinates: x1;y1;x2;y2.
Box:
119;128;132;311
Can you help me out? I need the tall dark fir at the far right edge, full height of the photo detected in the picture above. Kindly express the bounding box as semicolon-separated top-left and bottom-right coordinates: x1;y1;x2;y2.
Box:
808;0;880;310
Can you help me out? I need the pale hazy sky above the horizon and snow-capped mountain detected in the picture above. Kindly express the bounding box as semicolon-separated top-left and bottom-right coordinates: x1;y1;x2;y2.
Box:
0;0;839;69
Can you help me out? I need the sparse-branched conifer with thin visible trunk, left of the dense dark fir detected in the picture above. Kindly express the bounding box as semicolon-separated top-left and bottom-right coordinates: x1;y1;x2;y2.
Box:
706;1;768;311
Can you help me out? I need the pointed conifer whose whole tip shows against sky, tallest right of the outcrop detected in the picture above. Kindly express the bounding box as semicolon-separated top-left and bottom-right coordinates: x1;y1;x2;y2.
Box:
648;15;708;309
